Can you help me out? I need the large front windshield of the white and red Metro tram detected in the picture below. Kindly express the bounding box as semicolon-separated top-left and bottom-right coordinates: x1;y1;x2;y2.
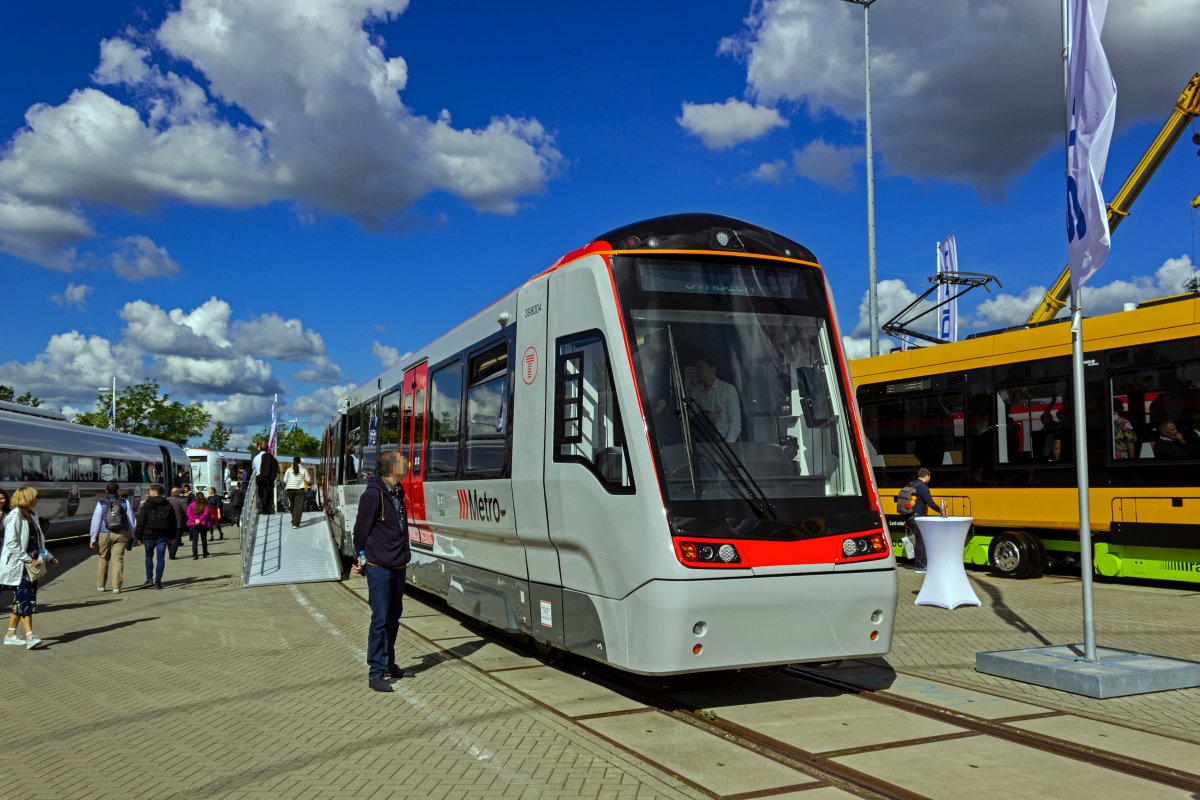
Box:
614;257;877;536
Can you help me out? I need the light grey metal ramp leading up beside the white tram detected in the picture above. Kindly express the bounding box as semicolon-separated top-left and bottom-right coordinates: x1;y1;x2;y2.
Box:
242;511;342;587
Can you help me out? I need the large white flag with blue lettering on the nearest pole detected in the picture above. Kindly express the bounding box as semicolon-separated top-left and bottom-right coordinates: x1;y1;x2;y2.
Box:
1067;0;1117;291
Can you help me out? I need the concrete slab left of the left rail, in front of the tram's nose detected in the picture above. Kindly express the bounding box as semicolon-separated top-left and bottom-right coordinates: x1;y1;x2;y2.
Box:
580;711;816;795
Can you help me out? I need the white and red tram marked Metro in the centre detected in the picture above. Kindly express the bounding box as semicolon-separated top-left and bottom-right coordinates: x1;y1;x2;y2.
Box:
324;215;896;674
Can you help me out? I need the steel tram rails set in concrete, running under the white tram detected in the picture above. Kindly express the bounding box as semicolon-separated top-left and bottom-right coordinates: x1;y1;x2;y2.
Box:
338;583;1200;800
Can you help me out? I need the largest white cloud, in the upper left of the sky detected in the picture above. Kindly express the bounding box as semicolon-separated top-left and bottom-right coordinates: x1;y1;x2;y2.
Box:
0;0;563;268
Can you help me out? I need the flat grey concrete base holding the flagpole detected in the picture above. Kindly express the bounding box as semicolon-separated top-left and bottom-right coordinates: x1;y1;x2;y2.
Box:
976;644;1200;698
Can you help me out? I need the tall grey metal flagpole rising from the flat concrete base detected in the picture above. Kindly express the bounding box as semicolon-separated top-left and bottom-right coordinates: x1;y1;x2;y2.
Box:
1062;0;1096;661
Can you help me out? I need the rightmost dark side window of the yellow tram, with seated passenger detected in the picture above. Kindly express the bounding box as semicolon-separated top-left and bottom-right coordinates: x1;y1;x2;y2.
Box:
1109;363;1200;461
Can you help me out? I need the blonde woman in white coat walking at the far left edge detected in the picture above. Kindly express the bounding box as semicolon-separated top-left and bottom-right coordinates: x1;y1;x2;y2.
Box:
0;486;59;650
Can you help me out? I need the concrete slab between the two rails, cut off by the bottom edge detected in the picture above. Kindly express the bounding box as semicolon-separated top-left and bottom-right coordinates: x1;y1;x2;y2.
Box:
834;736;1194;800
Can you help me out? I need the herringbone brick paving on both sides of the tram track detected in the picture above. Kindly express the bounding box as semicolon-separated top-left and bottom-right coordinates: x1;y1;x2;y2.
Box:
0;529;1200;800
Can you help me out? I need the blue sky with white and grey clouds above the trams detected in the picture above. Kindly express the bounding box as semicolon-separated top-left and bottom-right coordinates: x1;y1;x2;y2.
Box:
0;0;1200;443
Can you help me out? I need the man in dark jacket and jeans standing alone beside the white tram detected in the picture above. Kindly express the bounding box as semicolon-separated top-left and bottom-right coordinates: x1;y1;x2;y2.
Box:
350;451;413;692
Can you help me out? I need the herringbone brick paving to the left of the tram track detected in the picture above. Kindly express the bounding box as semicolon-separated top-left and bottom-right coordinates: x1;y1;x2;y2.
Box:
0;529;702;800
